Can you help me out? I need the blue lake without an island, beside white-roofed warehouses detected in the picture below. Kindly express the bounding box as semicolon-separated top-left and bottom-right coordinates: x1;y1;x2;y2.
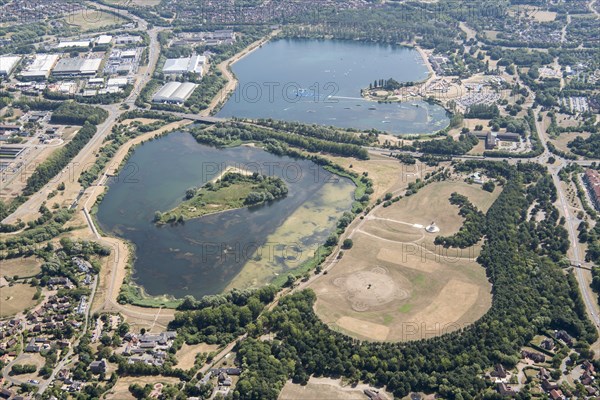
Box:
217;39;449;134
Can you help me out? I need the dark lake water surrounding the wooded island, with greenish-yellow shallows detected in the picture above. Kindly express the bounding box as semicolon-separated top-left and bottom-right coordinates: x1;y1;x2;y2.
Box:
97;132;354;298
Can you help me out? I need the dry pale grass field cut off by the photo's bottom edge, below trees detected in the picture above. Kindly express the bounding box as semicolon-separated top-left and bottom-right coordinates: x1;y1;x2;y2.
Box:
278;377;394;400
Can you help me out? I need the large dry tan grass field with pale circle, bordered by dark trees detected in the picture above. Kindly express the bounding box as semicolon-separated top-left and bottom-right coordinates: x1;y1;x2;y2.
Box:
311;181;500;341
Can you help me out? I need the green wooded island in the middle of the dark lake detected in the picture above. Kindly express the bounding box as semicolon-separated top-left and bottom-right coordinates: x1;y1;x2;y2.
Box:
154;167;288;224
